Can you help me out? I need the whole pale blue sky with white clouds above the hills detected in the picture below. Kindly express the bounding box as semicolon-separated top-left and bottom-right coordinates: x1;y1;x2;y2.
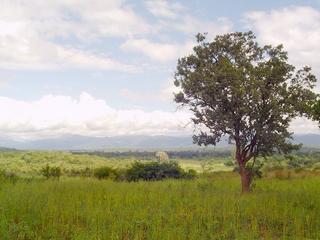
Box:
0;0;320;139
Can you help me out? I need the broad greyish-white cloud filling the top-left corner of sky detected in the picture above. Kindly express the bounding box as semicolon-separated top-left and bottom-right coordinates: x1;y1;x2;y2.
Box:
0;0;151;39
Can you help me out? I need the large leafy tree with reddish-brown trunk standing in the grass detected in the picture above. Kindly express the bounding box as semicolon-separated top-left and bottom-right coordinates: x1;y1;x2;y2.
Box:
175;32;316;192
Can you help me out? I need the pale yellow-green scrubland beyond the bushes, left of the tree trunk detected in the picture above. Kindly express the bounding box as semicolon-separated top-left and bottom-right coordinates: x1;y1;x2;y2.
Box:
0;150;232;178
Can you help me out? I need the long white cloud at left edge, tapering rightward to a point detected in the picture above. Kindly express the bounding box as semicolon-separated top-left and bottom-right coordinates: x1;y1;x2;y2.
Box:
0;36;138;72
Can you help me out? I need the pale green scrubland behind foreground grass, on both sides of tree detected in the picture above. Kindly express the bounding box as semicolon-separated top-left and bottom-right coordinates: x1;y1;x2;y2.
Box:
0;148;320;178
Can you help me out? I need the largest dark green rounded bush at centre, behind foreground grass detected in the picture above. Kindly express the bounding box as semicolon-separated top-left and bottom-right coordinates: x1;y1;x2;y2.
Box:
126;162;195;181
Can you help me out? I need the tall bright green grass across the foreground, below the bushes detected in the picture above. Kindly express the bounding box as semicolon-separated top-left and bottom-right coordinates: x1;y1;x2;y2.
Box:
0;173;320;240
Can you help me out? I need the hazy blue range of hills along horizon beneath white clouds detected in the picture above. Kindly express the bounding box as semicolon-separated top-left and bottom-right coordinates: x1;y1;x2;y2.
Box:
0;134;320;150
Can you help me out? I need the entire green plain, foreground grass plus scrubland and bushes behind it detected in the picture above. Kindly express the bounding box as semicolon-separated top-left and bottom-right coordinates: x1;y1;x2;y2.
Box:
0;148;320;240
